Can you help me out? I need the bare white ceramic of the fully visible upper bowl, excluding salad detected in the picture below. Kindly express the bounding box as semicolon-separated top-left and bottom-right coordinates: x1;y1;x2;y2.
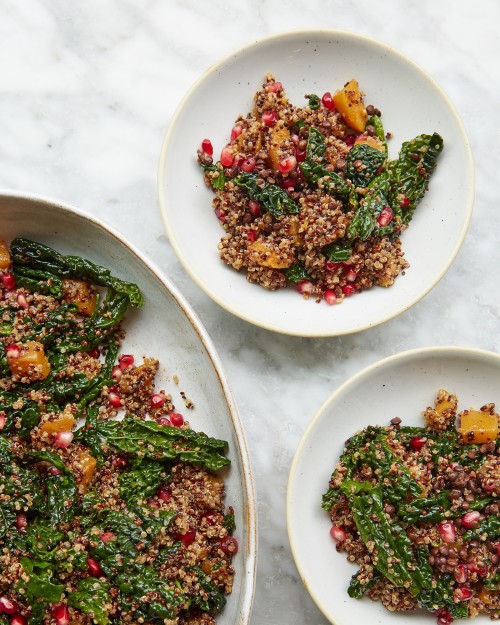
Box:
158;30;474;336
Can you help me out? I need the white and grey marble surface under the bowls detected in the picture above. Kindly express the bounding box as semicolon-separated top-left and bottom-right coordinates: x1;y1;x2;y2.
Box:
0;0;500;625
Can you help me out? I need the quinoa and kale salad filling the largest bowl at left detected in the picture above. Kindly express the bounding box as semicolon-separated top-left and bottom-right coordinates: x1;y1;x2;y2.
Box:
0;239;238;625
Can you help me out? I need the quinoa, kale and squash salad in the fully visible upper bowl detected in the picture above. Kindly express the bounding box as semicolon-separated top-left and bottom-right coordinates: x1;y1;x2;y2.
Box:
198;74;443;304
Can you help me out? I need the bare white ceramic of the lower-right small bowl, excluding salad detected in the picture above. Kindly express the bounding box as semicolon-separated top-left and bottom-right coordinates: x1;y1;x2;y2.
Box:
287;347;500;625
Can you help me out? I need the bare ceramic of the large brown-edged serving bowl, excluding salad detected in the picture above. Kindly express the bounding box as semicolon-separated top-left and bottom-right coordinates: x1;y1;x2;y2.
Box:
0;191;256;625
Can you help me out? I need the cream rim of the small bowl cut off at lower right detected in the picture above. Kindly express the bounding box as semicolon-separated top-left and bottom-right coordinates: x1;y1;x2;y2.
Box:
285;345;500;625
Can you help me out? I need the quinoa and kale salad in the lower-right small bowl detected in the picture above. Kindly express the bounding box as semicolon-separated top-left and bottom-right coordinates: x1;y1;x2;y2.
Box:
323;390;500;625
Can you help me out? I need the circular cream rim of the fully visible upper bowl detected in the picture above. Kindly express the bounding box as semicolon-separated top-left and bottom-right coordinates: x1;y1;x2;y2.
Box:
157;28;475;338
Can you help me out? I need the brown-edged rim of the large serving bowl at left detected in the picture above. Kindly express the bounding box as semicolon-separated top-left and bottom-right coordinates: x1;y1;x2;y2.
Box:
0;188;257;625
